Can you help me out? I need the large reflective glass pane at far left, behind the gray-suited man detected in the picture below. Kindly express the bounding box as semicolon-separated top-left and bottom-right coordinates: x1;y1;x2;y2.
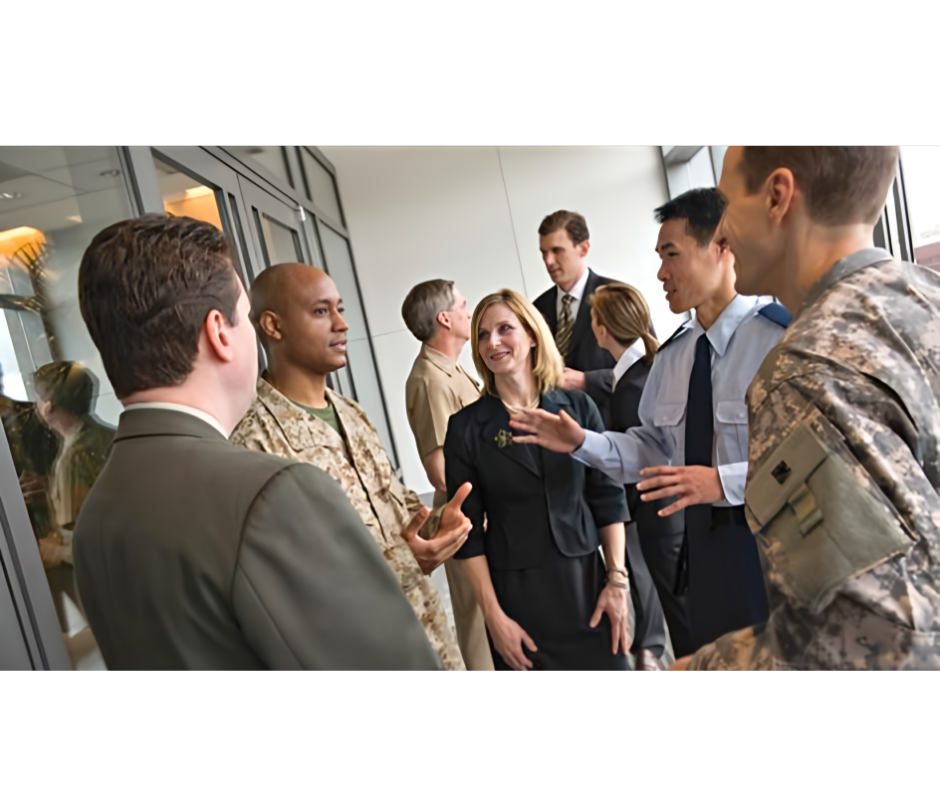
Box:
0;145;132;669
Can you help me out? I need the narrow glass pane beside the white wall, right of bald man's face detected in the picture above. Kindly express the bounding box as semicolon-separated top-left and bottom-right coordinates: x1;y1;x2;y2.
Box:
319;224;398;467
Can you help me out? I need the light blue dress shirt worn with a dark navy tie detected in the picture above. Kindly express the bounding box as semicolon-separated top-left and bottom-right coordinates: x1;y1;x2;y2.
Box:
572;295;784;506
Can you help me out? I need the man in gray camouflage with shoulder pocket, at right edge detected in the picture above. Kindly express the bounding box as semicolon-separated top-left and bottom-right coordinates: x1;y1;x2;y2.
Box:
688;146;940;670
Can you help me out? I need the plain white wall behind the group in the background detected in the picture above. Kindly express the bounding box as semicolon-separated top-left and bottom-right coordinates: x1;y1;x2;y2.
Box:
319;145;682;493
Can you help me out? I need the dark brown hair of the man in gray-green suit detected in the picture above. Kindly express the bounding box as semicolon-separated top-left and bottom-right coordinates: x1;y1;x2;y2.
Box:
78;214;240;399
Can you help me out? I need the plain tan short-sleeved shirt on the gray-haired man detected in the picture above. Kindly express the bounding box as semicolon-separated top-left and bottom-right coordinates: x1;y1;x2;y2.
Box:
405;345;480;506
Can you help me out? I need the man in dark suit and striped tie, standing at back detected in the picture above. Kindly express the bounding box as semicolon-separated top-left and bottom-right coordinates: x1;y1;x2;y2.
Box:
534;206;614;424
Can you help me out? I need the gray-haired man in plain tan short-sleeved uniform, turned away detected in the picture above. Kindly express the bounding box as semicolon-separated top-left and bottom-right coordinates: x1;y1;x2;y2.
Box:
401;279;493;670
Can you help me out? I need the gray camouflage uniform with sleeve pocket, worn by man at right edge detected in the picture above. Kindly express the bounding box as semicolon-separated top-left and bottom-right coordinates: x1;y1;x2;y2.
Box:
689;249;940;670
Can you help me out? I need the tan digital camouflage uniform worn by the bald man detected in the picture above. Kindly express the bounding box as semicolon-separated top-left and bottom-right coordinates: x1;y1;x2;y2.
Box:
231;380;465;670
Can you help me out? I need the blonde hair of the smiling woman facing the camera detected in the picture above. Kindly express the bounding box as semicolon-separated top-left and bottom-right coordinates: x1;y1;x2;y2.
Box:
470;290;565;397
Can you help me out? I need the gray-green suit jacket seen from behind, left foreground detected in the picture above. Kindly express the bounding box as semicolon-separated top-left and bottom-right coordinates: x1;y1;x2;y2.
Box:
73;409;439;670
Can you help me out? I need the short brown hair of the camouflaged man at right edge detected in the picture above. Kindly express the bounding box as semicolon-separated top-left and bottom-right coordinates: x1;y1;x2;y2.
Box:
740;145;900;227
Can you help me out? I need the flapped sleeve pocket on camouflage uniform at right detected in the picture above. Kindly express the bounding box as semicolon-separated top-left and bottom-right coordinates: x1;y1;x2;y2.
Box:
744;424;914;613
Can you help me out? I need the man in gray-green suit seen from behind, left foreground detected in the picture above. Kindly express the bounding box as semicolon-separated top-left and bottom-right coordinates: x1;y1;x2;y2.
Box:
73;215;439;670
